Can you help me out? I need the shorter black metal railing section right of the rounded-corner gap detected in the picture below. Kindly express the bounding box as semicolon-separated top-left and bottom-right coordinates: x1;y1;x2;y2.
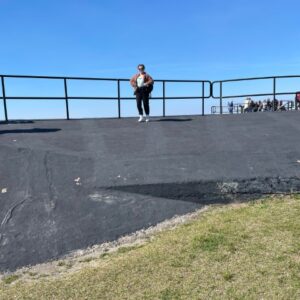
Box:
212;75;300;114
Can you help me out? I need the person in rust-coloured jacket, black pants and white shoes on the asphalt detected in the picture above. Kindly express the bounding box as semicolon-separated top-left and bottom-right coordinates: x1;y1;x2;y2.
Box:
130;64;154;122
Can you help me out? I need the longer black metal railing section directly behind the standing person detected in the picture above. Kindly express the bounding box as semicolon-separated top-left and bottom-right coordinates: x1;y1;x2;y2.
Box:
0;75;212;122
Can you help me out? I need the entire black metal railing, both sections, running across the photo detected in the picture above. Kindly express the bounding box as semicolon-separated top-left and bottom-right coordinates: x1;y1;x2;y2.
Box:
0;74;300;121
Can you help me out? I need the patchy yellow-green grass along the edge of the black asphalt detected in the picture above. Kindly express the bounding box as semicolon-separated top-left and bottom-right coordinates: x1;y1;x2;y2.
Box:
0;196;300;300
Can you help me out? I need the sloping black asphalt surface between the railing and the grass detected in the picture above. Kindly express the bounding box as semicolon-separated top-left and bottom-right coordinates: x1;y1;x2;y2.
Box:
0;112;300;271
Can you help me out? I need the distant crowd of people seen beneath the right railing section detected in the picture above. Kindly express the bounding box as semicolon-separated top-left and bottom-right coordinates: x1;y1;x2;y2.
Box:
228;98;292;114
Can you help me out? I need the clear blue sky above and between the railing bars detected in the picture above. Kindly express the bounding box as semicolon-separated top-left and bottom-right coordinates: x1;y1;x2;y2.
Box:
0;0;300;118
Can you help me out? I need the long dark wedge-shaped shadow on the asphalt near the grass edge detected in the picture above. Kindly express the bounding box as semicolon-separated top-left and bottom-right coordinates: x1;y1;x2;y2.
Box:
109;177;300;205
